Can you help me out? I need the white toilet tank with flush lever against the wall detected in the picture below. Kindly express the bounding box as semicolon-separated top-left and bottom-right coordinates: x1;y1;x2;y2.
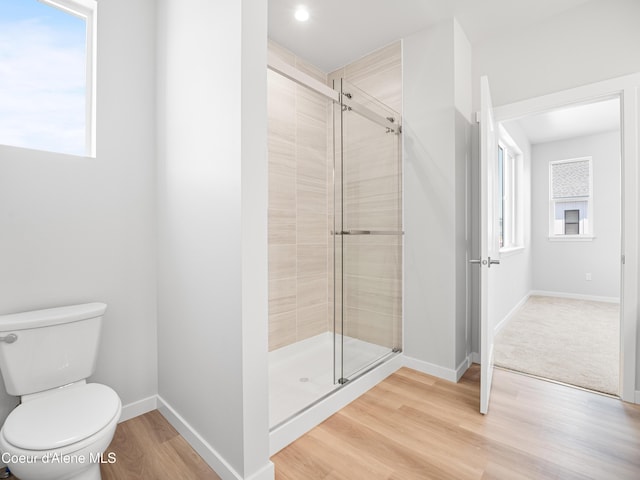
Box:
0;303;107;396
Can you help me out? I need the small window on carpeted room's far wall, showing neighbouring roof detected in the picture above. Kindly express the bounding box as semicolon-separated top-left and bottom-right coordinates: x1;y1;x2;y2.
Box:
549;157;593;239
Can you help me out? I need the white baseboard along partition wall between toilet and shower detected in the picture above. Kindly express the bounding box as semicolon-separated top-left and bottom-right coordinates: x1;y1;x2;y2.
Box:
158;396;274;480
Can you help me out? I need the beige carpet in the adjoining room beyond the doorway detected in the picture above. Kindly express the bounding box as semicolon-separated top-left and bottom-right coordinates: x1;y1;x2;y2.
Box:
494;296;620;395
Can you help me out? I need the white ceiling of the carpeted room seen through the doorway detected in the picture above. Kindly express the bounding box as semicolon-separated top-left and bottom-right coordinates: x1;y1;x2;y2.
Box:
506;97;620;145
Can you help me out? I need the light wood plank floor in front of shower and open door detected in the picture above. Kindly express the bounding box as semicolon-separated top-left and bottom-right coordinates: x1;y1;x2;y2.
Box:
272;365;640;480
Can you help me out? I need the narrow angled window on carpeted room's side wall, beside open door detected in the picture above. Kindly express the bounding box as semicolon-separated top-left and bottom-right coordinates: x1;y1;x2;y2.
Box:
497;128;523;251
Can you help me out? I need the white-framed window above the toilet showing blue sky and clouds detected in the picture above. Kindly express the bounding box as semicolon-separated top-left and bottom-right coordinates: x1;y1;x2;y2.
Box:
0;0;97;156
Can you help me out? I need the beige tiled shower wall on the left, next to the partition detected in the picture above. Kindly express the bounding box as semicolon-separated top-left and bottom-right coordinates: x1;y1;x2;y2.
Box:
268;42;332;350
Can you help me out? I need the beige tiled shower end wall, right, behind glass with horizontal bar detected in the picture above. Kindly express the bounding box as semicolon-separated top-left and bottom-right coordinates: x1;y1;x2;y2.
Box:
329;42;402;347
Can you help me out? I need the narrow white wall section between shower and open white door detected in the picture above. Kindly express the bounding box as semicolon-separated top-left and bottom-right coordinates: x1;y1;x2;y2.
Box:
402;20;470;376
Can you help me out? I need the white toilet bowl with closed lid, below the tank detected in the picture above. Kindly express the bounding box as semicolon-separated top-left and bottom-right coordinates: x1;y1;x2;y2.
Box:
0;382;122;480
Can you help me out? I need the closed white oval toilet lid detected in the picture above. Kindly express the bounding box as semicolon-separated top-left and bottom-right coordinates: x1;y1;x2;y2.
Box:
2;383;120;450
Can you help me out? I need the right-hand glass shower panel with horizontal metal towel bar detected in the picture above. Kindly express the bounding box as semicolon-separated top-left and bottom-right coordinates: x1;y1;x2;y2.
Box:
334;80;402;383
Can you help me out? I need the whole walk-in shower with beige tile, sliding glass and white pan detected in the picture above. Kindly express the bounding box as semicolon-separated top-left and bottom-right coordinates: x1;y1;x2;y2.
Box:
269;49;402;428
